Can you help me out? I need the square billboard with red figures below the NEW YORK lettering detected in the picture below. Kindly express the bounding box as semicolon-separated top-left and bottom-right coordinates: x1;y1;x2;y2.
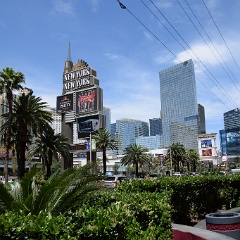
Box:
76;88;100;115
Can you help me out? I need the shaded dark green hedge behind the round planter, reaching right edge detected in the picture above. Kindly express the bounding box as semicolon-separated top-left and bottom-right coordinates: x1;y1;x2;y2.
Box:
117;174;240;225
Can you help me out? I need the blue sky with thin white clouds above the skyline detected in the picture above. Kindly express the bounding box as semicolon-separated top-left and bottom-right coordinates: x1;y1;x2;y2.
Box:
0;0;240;147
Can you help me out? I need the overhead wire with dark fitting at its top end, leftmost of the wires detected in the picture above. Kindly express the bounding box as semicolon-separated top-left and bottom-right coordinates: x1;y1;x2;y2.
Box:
117;0;230;110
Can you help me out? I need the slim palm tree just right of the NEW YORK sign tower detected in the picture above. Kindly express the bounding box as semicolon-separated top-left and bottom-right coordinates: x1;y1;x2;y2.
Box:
93;128;117;174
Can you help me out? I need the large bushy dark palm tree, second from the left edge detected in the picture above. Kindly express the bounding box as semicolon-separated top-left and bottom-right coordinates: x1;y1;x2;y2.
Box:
1;93;52;178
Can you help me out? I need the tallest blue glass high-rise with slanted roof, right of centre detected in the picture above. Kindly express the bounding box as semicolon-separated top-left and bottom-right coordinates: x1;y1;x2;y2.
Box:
159;60;199;150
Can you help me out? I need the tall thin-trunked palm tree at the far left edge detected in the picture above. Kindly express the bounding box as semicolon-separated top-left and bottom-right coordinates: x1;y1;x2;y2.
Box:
0;67;25;182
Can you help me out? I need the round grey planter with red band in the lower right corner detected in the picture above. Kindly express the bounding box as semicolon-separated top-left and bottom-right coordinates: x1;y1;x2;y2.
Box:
205;211;240;240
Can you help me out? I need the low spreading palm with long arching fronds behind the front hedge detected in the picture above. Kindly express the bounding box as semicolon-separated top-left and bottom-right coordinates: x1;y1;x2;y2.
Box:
0;165;104;215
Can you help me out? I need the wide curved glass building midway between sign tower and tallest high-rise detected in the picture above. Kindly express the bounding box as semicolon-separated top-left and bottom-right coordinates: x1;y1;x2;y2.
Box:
115;118;149;154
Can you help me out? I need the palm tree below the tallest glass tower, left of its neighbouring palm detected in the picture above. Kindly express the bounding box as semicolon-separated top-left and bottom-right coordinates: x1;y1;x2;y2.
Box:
167;143;186;172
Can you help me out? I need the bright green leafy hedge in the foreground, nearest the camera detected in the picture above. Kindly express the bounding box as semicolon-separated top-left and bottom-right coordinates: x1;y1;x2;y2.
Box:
0;192;172;240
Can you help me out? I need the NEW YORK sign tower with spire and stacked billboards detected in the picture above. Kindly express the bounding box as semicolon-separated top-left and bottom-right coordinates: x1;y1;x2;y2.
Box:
57;43;104;169
